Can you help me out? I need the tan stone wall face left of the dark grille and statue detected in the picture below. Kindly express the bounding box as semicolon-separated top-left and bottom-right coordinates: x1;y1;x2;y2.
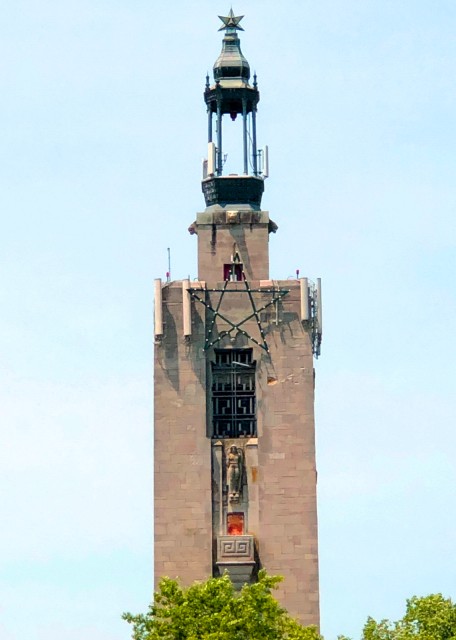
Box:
154;282;212;585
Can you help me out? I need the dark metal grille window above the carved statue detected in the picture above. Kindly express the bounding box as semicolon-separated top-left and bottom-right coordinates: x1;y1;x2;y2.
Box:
212;349;256;438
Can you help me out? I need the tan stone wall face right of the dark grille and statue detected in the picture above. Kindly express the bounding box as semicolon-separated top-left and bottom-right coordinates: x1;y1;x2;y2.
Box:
258;280;319;625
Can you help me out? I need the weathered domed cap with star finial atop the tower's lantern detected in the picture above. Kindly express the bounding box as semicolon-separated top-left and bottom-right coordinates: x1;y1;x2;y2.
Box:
214;9;250;83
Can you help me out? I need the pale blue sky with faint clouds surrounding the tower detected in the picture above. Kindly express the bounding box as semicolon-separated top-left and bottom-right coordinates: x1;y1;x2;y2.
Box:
0;0;456;640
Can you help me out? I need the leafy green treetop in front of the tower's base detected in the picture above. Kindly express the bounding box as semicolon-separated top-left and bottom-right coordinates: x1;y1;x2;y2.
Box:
123;571;322;640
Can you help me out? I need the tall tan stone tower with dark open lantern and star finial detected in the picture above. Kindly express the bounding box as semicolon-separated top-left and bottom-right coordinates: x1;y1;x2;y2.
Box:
155;11;321;625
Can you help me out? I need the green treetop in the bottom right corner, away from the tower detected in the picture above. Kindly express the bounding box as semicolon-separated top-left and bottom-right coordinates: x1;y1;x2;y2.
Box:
363;593;456;640
